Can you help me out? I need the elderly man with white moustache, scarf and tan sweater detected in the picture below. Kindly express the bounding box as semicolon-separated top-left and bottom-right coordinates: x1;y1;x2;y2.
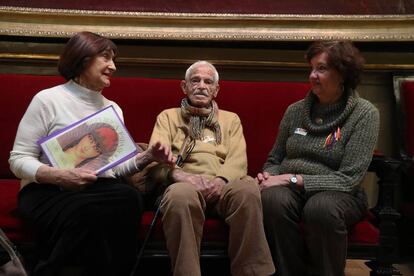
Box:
150;61;275;276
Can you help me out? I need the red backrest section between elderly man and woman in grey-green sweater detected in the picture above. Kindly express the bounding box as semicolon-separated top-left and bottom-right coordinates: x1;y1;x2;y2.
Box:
217;81;310;176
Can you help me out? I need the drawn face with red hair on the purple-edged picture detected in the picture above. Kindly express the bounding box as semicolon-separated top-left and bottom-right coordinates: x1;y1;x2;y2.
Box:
64;126;118;168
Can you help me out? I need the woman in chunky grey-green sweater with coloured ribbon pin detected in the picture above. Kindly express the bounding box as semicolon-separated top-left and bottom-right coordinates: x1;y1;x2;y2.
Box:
257;41;379;276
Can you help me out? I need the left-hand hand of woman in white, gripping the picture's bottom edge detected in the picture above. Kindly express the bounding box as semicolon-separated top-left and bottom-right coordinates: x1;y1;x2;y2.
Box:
36;165;97;190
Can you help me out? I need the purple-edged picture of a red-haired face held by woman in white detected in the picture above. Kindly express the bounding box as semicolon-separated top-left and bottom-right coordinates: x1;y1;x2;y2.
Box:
38;105;137;174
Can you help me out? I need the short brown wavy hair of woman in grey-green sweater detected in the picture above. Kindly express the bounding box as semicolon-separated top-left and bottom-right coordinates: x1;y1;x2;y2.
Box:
305;41;365;89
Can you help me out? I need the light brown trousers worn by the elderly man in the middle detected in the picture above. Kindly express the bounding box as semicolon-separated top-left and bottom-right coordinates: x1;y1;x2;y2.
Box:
161;177;275;276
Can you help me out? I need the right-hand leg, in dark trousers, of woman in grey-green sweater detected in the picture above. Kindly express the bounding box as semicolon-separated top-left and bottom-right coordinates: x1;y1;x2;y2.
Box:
303;191;367;276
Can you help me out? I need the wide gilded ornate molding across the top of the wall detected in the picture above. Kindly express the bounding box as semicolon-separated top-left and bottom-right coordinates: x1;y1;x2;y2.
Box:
0;6;414;41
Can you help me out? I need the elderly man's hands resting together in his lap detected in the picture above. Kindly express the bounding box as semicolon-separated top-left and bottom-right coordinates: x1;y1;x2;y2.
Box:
172;169;226;202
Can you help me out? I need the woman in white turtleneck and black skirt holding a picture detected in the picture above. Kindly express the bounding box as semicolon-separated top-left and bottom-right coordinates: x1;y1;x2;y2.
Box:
9;32;172;275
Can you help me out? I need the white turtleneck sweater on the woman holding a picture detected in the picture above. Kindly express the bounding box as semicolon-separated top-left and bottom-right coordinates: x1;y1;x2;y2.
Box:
9;81;137;187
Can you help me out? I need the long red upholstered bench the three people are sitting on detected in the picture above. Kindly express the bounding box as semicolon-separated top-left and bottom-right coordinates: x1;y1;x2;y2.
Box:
0;74;402;274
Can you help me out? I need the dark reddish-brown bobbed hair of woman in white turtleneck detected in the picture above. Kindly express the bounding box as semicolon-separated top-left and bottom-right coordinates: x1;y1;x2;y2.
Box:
58;32;117;80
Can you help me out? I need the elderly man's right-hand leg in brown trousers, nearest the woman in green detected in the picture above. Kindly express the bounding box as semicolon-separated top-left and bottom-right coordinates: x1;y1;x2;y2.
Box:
217;176;275;276
